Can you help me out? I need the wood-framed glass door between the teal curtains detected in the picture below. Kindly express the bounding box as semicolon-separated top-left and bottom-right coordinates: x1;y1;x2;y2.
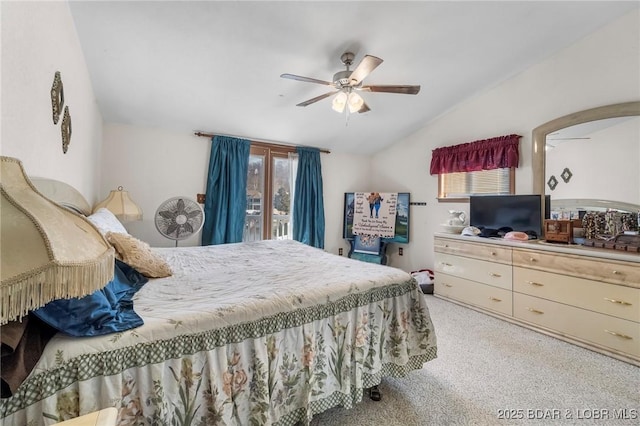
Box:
242;142;295;241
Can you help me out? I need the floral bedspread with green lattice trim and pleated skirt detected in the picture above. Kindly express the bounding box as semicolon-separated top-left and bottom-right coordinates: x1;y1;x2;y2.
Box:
0;241;437;426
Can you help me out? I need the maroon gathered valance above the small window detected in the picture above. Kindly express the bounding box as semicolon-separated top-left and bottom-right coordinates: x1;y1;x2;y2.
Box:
431;135;522;175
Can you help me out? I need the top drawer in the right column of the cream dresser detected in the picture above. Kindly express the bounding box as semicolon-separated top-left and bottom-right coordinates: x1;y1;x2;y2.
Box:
513;249;640;288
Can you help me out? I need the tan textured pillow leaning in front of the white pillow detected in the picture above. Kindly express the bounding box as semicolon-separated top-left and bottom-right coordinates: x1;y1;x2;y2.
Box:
106;232;173;278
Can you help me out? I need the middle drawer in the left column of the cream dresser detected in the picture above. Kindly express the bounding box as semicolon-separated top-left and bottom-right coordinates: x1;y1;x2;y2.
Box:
434;253;512;290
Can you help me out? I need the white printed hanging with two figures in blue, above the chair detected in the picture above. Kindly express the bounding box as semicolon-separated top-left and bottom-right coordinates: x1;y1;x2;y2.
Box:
352;192;398;238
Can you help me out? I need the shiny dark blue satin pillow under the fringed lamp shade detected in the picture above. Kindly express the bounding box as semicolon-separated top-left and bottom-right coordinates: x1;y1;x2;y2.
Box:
31;260;149;337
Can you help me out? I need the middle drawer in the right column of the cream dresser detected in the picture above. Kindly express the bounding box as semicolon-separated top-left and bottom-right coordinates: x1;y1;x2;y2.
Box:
513;266;640;327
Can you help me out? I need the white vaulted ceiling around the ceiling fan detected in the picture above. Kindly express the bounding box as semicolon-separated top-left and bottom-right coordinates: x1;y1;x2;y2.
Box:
70;1;638;155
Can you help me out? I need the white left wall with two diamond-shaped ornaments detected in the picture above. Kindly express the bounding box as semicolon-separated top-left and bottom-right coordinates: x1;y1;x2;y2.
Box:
0;1;102;203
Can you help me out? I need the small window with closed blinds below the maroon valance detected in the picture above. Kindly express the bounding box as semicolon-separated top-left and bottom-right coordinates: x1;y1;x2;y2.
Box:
438;167;515;201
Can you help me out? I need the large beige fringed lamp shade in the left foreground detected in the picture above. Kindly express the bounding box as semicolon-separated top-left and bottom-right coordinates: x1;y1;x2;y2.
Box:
0;157;115;325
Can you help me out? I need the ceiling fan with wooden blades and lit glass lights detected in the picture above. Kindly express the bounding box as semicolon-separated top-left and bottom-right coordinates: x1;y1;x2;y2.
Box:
280;52;420;113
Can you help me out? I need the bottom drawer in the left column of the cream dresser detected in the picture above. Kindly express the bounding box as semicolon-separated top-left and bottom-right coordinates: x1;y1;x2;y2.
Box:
434;273;512;316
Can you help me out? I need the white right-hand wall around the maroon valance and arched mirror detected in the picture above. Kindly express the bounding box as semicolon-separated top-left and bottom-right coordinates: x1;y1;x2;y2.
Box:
372;11;640;270
